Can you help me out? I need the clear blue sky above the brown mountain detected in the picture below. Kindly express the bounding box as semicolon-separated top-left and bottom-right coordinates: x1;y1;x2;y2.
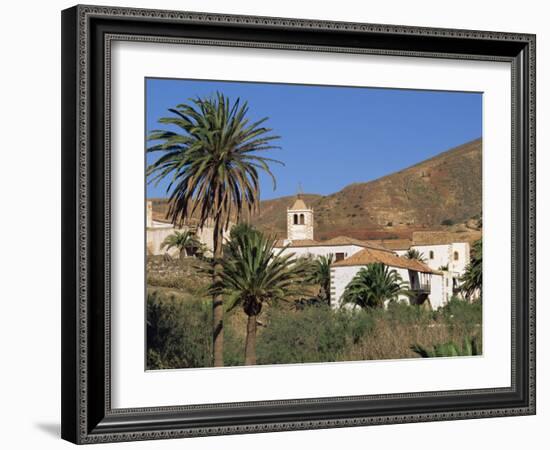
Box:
146;79;482;200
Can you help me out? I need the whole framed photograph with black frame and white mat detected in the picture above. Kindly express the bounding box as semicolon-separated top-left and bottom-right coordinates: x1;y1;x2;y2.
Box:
62;6;535;444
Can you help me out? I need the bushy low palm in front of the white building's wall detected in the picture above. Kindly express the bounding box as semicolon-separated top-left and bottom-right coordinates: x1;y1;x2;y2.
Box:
342;263;410;308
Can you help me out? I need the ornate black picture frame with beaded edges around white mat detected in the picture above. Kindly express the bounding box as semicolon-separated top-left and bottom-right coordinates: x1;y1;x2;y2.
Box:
62;6;535;444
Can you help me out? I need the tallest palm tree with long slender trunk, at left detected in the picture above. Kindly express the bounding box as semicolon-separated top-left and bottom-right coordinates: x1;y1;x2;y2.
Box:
147;93;279;366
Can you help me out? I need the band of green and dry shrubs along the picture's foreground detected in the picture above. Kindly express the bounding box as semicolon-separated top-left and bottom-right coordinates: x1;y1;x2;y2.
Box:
146;288;481;369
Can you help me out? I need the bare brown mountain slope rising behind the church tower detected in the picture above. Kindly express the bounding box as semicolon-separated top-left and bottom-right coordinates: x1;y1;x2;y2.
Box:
252;139;482;238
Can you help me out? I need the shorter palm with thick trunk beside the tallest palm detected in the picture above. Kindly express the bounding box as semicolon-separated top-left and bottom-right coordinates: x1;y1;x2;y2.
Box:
211;231;309;365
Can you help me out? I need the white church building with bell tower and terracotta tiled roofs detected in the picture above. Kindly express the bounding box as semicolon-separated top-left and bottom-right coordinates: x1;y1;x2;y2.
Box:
277;195;470;309
